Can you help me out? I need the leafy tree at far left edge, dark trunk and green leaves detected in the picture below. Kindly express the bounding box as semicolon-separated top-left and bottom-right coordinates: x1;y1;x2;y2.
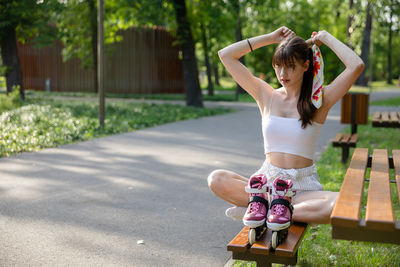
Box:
0;0;57;99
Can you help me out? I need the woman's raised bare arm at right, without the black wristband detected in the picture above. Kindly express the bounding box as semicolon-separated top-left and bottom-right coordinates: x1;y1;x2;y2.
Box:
313;31;364;110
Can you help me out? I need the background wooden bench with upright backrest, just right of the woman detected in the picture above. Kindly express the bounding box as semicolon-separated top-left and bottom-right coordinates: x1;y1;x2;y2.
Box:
332;93;369;163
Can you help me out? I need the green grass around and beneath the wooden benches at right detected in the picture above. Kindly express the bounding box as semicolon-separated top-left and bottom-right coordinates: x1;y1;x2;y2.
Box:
234;121;400;266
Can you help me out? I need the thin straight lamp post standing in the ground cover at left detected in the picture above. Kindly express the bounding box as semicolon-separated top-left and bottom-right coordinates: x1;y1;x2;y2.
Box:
97;0;105;128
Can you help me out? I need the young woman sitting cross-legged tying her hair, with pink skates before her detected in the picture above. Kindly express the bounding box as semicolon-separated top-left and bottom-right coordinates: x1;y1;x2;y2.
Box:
208;27;364;247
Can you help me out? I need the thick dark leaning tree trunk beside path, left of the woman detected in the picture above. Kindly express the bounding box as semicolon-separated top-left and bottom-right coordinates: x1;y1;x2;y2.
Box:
173;0;203;107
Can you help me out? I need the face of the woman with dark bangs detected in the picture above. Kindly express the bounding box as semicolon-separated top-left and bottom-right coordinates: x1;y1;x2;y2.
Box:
274;59;309;88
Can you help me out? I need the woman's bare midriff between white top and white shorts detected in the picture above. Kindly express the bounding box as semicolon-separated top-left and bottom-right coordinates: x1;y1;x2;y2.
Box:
265;152;313;169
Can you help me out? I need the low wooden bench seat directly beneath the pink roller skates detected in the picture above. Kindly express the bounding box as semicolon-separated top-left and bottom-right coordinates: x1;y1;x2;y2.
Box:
227;222;307;266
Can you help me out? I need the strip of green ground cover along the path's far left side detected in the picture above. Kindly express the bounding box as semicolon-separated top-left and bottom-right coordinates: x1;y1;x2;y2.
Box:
0;96;232;157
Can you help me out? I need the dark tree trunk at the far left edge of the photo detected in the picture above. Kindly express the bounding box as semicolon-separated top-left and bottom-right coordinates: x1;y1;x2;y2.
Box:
1;25;25;100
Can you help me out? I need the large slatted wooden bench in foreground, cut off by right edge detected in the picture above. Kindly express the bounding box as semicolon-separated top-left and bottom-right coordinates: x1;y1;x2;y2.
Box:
331;148;400;244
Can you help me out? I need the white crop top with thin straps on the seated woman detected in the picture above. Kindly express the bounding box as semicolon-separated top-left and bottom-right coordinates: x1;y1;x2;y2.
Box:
262;94;324;160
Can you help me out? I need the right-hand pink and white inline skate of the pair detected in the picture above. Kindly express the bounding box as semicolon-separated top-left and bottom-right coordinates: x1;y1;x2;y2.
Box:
267;177;296;250
